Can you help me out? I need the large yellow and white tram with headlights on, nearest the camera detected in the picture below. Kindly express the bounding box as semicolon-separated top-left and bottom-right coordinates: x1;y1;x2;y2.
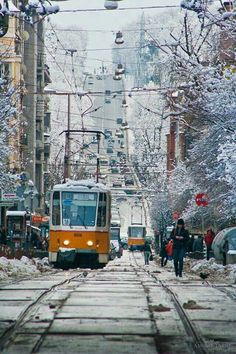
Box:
49;181;111;268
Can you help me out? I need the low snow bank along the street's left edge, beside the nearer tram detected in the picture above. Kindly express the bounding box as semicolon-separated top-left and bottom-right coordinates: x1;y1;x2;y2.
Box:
0;256;51;280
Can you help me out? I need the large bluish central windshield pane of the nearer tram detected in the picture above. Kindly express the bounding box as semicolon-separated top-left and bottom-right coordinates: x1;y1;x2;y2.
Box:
62;192;97;227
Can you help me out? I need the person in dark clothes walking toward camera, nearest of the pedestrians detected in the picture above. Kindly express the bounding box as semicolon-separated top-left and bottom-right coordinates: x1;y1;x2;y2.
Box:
170;219;189;277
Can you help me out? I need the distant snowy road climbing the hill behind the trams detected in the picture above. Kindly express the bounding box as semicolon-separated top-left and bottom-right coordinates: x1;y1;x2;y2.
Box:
85;75;150;237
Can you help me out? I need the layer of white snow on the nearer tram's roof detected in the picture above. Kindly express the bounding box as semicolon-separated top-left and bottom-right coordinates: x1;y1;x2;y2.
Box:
53;180;108;192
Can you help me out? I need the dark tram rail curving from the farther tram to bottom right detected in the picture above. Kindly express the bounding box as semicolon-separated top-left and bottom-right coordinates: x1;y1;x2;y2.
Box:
132;253;209;354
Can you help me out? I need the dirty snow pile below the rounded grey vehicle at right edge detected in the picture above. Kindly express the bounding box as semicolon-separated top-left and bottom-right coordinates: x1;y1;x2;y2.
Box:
190;258;236;282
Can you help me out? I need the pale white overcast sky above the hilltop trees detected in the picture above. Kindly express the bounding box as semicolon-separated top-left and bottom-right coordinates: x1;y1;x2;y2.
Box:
52;0;180;67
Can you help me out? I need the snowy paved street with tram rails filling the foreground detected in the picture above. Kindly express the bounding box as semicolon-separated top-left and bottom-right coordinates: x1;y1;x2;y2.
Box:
0;251;236;354
